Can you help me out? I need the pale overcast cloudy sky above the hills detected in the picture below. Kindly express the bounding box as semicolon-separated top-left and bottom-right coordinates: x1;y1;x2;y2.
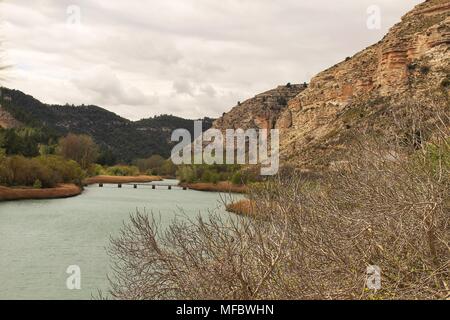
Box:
0;0;422;120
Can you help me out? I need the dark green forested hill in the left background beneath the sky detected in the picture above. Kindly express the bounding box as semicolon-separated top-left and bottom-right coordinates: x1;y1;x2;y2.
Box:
0;88;213;162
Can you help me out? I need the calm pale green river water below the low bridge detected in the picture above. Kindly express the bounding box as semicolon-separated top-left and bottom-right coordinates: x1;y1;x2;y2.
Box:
0;181;239;299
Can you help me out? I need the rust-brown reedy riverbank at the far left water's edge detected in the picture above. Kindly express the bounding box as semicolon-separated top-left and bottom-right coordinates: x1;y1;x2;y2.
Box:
0;184;82;201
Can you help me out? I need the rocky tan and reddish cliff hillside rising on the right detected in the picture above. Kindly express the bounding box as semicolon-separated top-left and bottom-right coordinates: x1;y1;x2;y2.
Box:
214;0;450;170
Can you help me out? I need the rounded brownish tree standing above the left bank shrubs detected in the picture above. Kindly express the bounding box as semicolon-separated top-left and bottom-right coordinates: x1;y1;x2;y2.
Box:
58;133;98;169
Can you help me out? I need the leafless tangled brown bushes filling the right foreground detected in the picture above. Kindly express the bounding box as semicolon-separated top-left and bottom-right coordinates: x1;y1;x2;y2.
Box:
110;97;450;299
